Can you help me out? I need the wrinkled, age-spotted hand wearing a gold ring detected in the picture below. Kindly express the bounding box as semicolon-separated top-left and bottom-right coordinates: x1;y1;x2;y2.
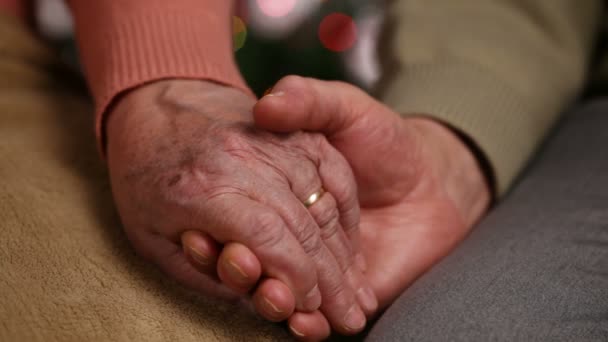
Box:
106;80;377;333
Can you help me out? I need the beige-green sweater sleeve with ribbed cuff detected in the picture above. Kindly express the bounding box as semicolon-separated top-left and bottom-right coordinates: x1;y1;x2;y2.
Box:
382;0;603;195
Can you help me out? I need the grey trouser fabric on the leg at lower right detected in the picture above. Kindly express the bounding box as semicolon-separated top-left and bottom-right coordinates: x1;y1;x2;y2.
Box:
367;100;608;342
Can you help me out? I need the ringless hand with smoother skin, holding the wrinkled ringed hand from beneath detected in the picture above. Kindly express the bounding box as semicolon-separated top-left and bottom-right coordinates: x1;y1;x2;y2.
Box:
254;76;490;338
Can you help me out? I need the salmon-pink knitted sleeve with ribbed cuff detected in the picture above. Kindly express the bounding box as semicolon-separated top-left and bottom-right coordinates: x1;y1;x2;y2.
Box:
64;0;251;150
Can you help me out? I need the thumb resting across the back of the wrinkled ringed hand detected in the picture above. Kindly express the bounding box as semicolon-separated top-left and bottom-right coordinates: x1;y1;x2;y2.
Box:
253;76;375;139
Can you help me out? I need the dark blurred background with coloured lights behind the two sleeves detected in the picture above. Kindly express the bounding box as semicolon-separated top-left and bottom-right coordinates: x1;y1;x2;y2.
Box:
36;0;383;95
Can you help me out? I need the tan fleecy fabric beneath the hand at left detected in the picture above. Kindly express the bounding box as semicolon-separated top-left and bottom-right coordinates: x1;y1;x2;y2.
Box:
0;15;289;342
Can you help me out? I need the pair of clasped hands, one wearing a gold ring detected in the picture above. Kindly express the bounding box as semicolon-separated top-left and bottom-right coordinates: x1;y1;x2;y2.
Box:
107;77;490;340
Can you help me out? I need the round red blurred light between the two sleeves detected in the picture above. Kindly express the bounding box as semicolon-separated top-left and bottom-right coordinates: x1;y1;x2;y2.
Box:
319;13;357;52
